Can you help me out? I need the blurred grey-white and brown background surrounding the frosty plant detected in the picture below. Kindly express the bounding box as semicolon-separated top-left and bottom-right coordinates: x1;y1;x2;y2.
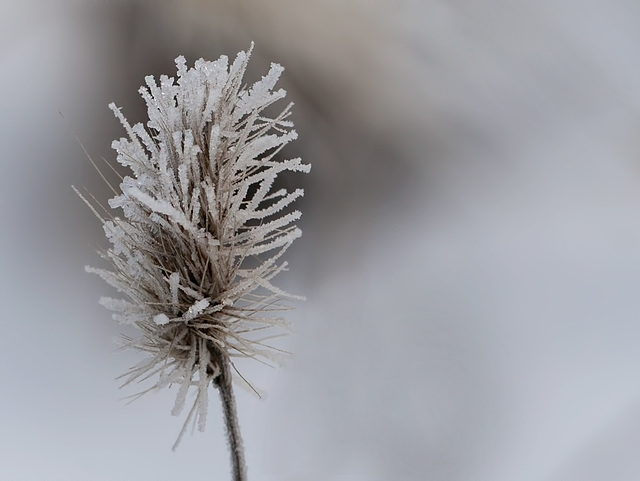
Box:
0;0;640;481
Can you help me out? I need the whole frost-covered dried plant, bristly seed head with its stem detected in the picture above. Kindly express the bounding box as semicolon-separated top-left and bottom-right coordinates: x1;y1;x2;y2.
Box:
75;44;309;480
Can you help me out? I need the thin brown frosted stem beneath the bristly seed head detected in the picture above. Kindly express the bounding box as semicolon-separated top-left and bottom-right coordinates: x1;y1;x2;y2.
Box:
215;356;247;481
